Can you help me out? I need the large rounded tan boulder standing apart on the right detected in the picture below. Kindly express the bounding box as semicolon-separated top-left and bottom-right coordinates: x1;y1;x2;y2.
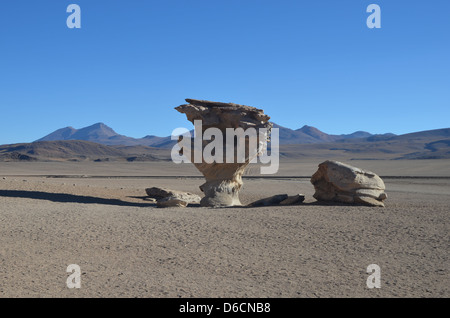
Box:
311;161;387;206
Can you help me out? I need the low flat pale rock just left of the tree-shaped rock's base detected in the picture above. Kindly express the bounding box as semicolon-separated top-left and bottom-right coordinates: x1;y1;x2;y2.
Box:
145;187;201;207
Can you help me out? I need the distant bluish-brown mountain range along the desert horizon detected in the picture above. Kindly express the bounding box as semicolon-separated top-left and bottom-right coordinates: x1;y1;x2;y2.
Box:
0;123;450;162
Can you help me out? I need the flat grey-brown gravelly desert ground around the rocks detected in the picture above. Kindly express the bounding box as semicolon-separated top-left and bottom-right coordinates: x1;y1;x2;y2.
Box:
0;160;450;298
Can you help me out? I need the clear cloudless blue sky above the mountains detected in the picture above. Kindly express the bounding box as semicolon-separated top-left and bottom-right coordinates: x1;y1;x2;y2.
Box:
0;0;450;144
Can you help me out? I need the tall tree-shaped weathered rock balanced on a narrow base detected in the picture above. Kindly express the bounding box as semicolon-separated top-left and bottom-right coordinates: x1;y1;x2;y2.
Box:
175;99;272;207
